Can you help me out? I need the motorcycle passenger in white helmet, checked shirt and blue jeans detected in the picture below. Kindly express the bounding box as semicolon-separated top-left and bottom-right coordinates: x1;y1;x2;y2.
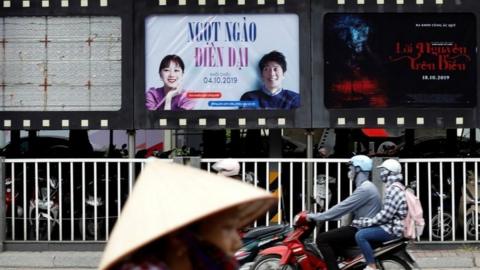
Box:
352;158;407;270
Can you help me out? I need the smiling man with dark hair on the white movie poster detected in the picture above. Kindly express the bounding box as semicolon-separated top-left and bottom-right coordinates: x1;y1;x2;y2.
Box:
240;51;300;109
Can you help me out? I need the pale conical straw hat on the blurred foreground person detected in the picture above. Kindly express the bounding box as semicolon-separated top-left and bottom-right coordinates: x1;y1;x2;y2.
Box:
99;160;276;269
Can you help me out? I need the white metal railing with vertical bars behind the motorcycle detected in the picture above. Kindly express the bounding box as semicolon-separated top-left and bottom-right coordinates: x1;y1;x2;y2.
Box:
4;158;480;243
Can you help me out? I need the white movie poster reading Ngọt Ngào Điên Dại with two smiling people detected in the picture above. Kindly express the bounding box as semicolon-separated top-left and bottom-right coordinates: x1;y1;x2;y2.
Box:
145;14;300;111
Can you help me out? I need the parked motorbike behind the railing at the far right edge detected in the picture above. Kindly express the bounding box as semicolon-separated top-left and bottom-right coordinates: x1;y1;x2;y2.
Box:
458;172;480;239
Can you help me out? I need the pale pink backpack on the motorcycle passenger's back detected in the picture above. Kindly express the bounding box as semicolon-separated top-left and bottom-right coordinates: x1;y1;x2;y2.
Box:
393;182;425;239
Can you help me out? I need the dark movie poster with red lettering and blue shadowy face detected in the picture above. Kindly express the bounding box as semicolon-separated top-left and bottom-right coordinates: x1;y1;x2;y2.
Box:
324;13;476;108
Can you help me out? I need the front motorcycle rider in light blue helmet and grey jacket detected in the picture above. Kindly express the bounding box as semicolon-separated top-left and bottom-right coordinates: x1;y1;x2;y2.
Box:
307;155;382;270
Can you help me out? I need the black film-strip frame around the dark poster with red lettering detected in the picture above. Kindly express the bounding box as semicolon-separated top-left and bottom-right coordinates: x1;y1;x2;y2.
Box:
311;0;480;128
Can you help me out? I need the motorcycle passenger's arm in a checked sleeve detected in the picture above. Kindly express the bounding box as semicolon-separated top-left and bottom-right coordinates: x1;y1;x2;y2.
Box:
352;185;405;227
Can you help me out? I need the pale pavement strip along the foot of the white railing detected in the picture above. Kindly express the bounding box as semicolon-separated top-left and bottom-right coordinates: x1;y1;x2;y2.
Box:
0;245;480;270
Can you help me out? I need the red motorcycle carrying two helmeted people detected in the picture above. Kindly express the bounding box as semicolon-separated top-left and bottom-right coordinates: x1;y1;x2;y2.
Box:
252;212;418;270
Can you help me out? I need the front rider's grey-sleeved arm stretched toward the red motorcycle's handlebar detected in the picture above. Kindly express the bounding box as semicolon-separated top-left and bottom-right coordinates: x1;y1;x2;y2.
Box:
307;182;370;222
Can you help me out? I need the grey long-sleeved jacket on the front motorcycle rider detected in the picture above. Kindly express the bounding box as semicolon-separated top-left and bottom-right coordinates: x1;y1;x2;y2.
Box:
308;172;382;222
